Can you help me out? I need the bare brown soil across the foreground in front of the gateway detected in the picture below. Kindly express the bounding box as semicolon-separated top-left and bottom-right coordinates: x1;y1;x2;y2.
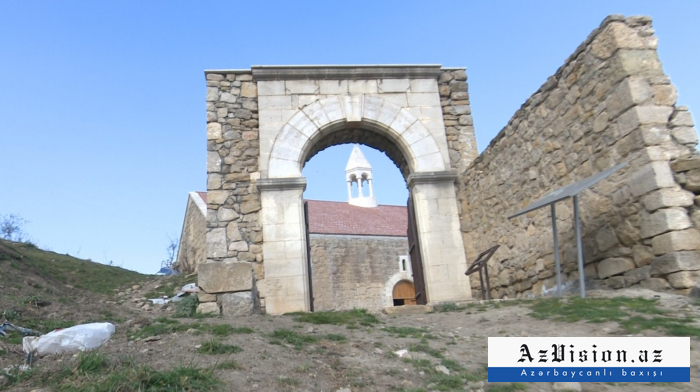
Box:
0;282;700;392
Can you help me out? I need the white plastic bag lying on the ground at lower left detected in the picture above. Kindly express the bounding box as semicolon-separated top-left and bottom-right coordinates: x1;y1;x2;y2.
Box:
22;323;114;357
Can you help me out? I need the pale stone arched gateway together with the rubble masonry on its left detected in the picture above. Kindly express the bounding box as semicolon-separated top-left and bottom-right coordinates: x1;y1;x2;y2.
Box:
202;65;471;314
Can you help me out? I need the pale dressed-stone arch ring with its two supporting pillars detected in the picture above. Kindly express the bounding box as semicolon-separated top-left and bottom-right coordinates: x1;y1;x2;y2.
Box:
257;94;471;314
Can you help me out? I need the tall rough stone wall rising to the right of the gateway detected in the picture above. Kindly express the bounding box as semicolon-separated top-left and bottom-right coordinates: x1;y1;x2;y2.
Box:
458;16;700;297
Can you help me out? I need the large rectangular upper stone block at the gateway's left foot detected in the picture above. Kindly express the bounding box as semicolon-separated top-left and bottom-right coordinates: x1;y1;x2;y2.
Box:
198;263;253;294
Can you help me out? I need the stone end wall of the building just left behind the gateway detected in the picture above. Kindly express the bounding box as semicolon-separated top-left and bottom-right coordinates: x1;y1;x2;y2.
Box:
175;196;207;273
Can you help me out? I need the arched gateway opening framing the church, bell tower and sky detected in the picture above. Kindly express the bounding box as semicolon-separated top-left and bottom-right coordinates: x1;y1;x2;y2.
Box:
302;144;411;311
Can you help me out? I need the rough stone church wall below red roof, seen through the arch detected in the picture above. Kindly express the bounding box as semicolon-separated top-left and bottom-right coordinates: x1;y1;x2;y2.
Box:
310;234;408;311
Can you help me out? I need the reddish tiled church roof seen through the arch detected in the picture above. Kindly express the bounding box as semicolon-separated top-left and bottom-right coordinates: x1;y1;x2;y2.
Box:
306;200;408;237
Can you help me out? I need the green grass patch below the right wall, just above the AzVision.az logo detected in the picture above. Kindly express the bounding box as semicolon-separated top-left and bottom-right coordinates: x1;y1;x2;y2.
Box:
530;297;700;337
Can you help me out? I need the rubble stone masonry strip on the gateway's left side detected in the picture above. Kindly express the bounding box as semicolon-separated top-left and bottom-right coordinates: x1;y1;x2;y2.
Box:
204;71;264;314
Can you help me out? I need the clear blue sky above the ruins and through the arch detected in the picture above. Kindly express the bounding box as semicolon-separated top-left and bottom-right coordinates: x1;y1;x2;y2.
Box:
0;0;700;272
